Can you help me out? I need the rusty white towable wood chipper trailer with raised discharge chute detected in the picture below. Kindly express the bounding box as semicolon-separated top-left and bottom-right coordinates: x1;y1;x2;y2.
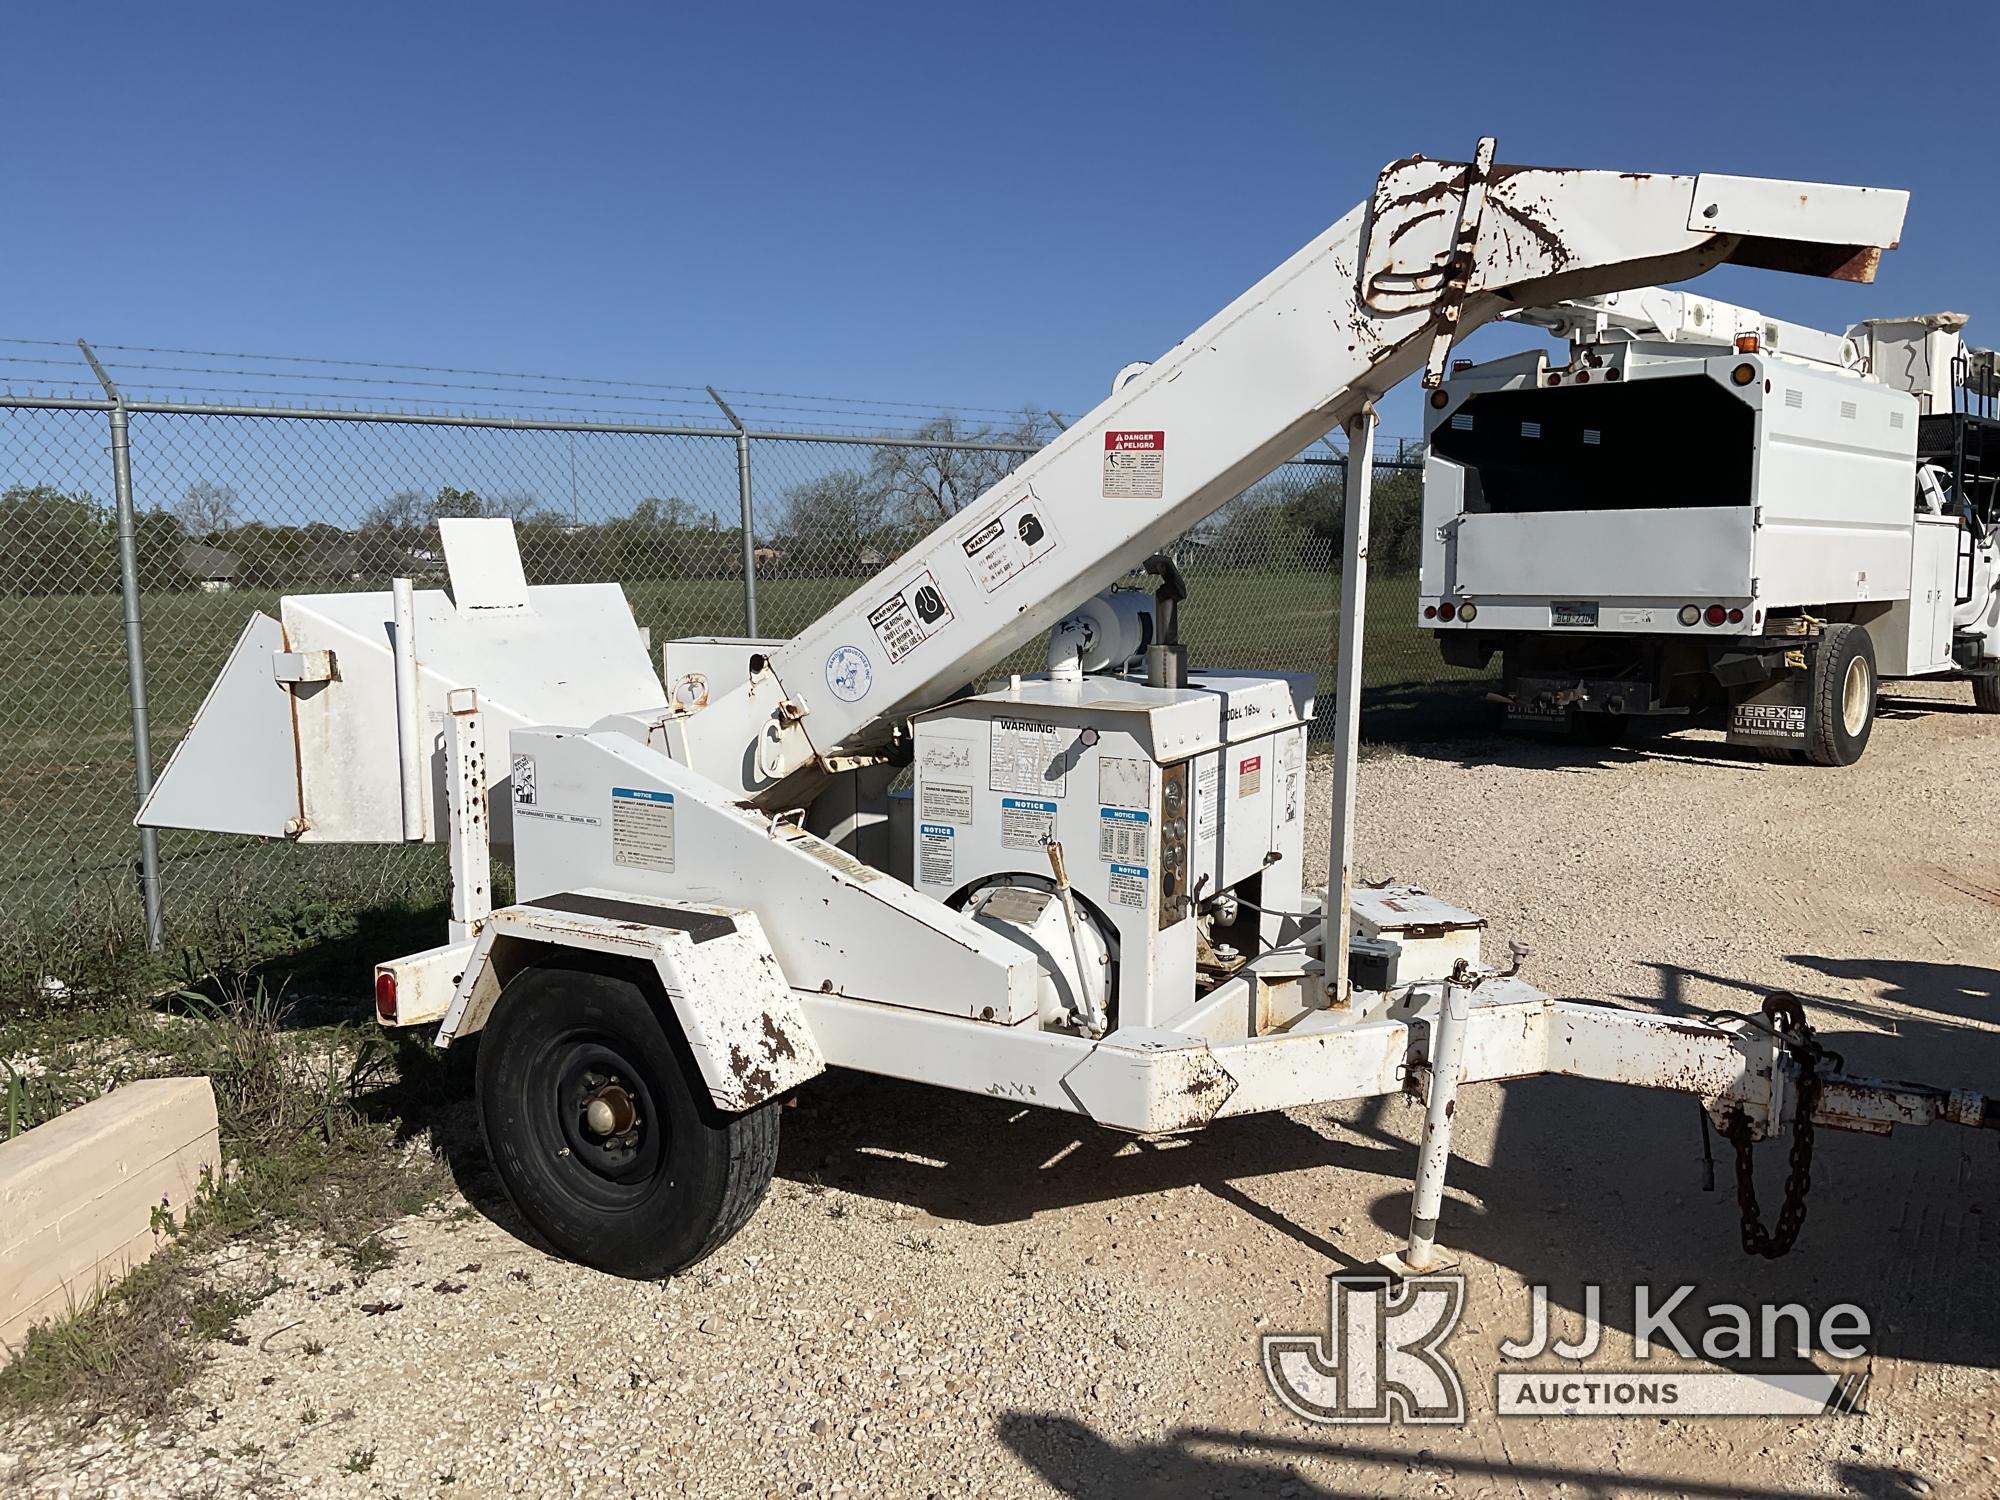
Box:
140;140;2000;1276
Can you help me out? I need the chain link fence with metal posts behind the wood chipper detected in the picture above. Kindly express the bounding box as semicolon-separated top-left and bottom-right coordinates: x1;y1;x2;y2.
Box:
0;394;1486;972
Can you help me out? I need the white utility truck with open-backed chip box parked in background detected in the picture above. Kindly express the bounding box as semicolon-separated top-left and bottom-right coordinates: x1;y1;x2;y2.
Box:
1418;286;2000;766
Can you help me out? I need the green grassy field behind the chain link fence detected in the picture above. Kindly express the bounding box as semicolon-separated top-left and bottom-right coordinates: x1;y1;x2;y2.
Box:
0;570;1472;972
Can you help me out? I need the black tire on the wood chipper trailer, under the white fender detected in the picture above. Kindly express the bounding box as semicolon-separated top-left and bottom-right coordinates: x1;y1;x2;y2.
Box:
478;954;778;1280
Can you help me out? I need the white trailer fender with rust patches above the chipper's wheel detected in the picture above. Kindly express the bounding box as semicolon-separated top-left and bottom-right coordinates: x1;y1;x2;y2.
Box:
438;890;826;1114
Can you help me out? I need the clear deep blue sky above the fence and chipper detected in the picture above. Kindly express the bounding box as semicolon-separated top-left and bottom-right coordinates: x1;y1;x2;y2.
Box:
0;4;2000;432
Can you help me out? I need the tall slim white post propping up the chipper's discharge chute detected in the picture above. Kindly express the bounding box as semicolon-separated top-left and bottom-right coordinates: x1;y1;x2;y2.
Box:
1326;400;1376;1004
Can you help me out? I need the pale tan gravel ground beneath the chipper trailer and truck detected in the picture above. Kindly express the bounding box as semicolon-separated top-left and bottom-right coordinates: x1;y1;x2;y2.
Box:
0;688;2000;1498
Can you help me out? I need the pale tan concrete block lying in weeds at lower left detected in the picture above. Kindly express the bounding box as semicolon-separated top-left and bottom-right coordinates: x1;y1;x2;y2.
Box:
0;1078;222;1364
